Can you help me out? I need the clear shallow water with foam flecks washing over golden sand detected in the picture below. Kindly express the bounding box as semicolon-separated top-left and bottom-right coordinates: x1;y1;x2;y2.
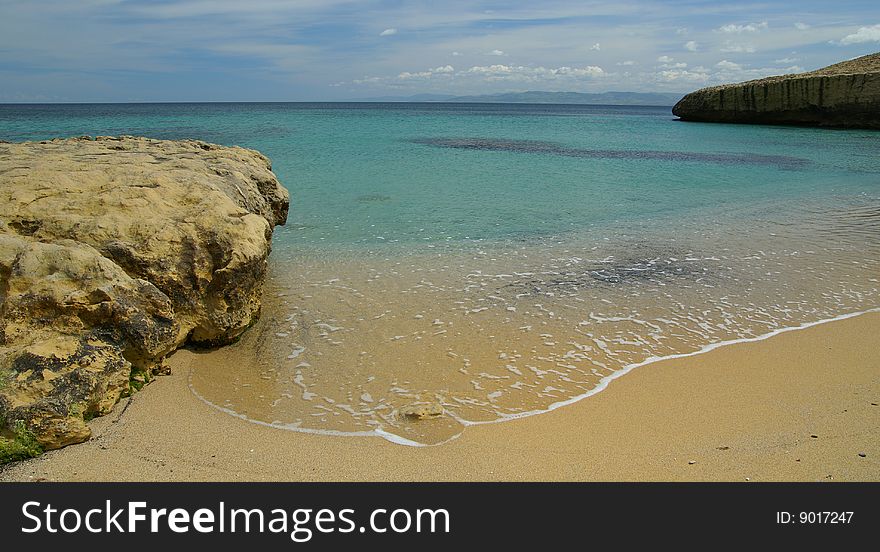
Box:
190;240;880;444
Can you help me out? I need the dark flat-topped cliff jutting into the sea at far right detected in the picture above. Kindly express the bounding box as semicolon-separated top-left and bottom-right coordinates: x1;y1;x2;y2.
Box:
672;53;880;129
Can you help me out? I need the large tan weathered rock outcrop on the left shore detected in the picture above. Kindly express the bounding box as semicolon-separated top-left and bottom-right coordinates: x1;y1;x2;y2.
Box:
0;137;288;449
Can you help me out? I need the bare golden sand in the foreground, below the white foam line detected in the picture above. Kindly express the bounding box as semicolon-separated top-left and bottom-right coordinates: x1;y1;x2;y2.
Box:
0;313;880;481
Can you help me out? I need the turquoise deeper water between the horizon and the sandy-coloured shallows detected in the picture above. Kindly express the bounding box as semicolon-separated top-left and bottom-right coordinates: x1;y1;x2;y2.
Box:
0;104;880;247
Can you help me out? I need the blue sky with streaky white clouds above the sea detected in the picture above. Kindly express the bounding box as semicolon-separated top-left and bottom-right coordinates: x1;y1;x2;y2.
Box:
0;0;880;102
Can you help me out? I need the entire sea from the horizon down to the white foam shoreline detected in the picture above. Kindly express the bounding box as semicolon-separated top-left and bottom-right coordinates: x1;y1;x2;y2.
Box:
0;104;880;444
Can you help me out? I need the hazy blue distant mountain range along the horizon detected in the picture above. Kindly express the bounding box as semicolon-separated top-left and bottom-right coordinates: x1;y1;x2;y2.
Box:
352;91;683;106
